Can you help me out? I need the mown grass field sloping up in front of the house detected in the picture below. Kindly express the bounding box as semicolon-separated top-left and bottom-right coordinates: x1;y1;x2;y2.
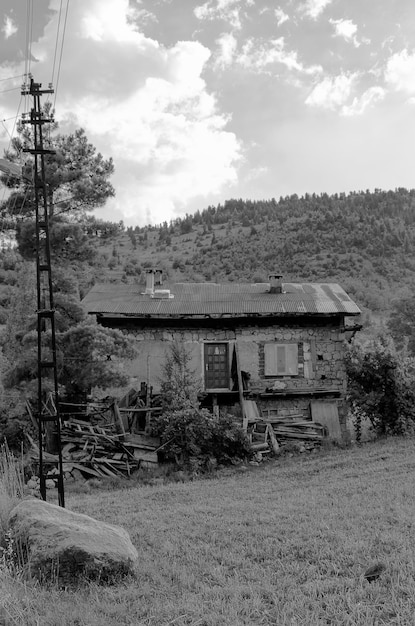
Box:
0;439;415;626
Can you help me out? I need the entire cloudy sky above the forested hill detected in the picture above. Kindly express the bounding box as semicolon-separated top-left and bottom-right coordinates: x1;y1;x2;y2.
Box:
0;0;415;226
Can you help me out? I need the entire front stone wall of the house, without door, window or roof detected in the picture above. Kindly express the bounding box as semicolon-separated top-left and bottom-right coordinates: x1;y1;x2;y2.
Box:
95;319;347;439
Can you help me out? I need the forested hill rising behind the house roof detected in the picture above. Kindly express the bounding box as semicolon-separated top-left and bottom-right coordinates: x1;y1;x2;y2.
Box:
0;189;415;316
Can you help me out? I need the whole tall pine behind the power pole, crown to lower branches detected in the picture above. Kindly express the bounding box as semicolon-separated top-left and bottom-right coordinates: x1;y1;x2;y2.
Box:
2;119;134;400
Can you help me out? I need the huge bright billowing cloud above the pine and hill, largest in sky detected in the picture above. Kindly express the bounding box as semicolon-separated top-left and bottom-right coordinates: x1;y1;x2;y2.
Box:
17;0;242;224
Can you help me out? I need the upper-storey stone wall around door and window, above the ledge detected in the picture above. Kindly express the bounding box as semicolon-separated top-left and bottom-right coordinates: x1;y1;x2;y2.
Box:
122;326;346;394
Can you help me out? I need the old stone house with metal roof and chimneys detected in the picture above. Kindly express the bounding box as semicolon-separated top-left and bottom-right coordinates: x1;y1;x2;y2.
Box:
83;270;360;438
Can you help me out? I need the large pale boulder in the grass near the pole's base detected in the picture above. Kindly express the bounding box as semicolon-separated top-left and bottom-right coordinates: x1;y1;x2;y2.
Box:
9;499;138;583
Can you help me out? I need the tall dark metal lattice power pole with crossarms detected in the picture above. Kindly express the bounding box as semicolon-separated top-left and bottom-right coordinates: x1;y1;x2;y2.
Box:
22;78;65;507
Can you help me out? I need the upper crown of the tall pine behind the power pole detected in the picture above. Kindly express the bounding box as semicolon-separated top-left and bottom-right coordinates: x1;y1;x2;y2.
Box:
0;116;115;262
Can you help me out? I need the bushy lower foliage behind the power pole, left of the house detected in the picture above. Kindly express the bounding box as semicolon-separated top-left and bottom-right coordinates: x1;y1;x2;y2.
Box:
3;280;135;402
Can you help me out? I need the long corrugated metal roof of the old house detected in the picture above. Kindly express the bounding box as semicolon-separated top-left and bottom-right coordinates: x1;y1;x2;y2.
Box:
83;283;360;317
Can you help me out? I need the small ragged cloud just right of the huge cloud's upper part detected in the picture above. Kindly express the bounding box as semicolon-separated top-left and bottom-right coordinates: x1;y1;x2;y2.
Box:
237;37;322;74
